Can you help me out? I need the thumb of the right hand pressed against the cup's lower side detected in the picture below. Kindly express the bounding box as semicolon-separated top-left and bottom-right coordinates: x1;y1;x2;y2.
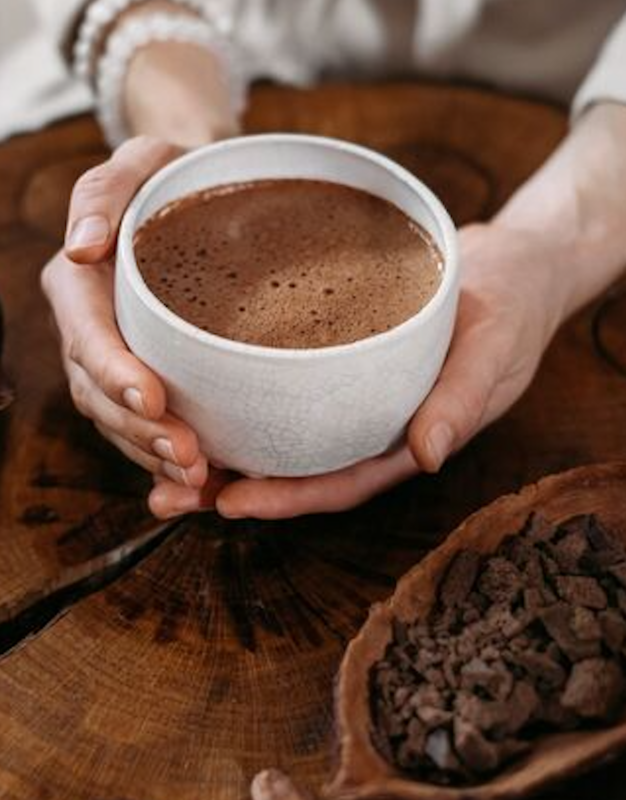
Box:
408;318;501;472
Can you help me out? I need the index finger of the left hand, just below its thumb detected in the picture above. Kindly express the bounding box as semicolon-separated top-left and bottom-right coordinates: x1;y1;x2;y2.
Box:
42;255;166;419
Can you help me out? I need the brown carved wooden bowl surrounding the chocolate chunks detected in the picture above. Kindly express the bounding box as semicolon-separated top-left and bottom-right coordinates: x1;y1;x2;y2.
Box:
326;463;626;800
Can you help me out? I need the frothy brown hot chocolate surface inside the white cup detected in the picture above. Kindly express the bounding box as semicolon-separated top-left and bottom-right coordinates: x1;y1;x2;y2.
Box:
135;180;441;347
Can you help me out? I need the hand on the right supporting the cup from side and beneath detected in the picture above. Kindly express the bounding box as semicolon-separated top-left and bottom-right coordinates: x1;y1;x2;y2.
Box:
153;223;565;519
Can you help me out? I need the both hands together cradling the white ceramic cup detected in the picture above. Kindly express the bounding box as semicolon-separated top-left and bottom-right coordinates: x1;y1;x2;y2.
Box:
42;137;560;519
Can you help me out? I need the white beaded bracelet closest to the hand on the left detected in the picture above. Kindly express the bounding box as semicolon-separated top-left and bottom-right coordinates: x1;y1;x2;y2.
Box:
96;12;247;147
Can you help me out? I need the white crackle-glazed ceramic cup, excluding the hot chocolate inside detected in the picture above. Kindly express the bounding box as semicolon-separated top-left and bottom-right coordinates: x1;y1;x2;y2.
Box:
115;134;459;476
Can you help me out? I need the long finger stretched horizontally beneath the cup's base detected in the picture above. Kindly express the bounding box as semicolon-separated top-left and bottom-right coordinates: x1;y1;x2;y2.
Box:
212;446;418;519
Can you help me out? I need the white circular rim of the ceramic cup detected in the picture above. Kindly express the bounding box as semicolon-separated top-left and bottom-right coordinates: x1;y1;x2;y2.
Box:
116;133;459;361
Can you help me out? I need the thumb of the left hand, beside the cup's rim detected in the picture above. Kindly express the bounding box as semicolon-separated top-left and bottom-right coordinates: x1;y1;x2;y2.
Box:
65;136;182;264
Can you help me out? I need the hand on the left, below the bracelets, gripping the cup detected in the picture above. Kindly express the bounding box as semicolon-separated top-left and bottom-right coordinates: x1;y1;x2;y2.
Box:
42;137;223;518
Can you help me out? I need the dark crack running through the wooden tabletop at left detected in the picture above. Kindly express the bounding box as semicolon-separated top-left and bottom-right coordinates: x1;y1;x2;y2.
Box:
0;517;186;661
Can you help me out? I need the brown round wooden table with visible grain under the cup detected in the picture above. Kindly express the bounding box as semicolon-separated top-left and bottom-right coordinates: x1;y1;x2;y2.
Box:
0;84;626;800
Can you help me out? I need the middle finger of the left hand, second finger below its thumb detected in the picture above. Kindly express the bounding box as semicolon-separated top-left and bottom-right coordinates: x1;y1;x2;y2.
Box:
66;361;199;466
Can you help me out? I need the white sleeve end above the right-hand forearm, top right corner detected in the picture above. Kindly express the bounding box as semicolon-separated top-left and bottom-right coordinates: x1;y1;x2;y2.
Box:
572;14;626;119
